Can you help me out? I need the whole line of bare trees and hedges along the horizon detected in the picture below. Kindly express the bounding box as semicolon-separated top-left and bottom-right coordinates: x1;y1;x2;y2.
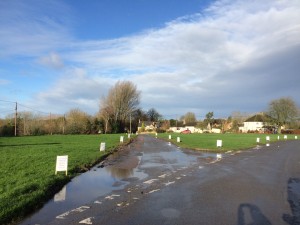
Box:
0;81;300;136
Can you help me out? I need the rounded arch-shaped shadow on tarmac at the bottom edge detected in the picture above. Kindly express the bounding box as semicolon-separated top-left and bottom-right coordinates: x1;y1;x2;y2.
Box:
237;203;272;225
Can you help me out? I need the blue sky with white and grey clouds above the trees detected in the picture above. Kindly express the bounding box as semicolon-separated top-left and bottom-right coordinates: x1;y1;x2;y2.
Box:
0;0;300;119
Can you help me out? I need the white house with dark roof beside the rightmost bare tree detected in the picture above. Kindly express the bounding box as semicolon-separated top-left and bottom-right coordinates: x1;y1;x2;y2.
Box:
239;113;272;133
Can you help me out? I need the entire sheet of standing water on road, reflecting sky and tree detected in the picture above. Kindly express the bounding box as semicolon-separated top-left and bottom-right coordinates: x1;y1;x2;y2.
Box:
21;136;216;225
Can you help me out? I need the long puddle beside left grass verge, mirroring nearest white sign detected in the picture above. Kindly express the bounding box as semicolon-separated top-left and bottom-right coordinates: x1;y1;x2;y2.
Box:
21;154;148;225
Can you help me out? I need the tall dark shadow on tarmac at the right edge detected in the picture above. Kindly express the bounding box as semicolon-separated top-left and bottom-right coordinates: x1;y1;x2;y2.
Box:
282;178;300;225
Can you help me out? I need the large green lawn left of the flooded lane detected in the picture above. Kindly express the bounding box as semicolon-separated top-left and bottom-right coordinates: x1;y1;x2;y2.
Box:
0;134;127;224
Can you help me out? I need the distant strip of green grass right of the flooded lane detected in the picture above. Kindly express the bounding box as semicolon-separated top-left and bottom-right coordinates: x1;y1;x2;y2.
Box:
157;133;295;151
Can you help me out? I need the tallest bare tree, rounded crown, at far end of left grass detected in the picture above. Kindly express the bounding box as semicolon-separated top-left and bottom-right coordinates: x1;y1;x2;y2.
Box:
99;81;140;133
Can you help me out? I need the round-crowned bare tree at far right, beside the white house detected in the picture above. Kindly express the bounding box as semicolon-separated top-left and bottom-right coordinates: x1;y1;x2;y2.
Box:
268;97;298;133
